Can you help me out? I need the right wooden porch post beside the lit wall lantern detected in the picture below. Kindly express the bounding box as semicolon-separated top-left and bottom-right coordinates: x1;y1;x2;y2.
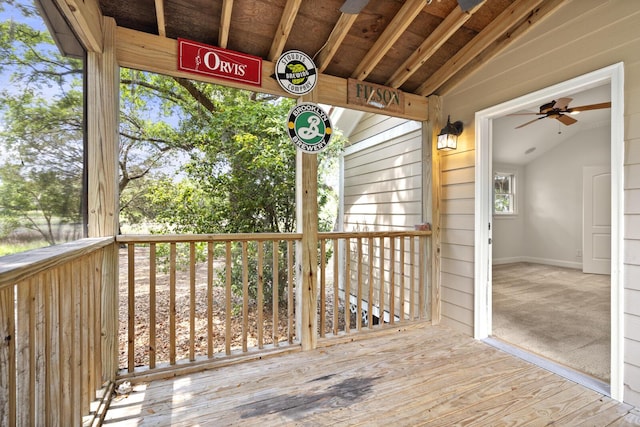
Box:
423;95;442;325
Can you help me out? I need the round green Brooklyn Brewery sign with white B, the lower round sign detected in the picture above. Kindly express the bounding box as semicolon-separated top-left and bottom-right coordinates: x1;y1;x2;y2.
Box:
287;102;333;153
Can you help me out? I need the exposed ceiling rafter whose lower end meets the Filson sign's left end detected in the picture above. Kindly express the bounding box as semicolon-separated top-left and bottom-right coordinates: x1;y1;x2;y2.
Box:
351;0;426;80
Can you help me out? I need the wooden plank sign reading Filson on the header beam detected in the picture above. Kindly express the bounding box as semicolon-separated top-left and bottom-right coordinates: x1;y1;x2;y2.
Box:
347;79;404;113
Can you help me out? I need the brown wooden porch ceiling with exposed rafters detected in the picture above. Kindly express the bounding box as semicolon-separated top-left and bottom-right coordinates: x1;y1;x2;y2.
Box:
99;0;562;96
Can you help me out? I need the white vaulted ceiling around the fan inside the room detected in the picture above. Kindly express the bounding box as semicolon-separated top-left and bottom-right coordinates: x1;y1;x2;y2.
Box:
492;84;611;165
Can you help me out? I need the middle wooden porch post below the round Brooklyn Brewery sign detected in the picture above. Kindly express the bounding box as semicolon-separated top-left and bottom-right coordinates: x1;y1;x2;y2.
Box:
296;91;318;351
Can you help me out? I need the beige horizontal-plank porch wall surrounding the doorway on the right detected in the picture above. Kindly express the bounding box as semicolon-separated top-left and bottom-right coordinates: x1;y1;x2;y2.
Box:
441;0;640;406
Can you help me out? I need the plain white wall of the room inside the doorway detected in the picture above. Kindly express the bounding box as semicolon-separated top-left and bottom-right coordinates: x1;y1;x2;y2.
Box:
493;124;611;269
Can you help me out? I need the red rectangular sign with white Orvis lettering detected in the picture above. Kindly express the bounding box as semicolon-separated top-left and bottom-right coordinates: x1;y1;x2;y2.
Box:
178;39;262;86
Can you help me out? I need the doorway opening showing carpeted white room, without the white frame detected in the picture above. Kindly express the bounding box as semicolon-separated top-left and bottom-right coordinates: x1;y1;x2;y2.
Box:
492;83;611;385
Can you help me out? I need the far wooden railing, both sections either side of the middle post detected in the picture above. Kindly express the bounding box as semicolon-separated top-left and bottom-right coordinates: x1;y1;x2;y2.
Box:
117;231;430;378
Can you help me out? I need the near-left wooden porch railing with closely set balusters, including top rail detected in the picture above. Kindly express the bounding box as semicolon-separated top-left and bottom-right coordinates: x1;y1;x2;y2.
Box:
0;237;115;426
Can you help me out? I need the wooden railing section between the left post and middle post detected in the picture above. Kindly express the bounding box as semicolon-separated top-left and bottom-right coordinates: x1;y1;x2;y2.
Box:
117;233;301;378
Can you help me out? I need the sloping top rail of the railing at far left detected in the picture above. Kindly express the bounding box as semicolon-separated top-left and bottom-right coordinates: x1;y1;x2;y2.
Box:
0;237;114;289
